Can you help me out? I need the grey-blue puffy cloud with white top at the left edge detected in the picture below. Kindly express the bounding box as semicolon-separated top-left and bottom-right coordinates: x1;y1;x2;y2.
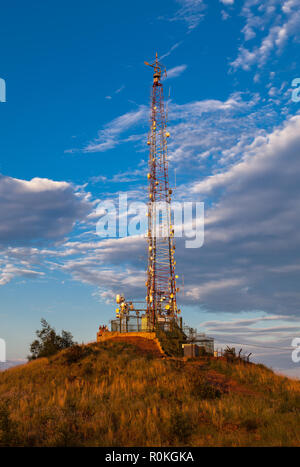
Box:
0;175;92;246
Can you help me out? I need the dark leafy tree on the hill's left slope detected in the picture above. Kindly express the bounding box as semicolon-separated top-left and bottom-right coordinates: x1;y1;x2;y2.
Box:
28;318;76;360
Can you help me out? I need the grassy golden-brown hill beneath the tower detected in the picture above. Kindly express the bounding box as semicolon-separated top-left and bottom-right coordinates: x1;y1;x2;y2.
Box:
0;341;300;447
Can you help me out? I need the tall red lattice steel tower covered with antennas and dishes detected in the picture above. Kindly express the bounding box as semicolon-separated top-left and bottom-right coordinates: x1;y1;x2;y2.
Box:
145;54;180;328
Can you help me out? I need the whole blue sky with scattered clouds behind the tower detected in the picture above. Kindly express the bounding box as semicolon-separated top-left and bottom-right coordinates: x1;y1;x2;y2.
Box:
0;0;300;374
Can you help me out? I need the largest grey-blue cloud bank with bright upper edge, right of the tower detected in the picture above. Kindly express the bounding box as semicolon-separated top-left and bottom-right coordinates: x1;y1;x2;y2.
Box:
185;116;300;314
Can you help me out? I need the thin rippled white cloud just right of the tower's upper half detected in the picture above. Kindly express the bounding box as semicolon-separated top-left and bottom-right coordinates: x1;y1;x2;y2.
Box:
164;93;275;169
